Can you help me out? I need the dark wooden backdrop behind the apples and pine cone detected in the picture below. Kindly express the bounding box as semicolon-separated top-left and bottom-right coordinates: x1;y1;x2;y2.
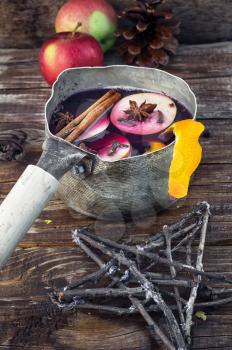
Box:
0;0;232;48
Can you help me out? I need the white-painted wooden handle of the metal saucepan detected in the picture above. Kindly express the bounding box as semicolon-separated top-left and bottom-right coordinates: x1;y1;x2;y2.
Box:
0;165;59;267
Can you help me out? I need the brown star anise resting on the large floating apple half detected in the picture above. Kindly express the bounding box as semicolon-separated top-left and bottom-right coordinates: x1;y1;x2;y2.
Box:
125;100;157;121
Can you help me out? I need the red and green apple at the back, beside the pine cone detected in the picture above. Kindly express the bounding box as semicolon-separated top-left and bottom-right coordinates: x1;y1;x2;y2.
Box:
55;0;117;51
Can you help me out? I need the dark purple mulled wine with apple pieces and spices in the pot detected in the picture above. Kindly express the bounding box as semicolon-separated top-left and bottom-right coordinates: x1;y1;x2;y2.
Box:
50;87;192;161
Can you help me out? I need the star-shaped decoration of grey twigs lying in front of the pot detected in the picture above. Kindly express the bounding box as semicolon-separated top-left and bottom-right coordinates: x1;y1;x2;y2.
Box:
51;202;221;350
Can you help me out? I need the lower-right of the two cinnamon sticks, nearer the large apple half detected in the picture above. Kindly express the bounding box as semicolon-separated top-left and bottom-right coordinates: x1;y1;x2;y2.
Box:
65;92;122;142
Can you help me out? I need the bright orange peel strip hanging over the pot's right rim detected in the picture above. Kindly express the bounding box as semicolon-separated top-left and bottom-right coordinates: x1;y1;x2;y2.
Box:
165;119;205;198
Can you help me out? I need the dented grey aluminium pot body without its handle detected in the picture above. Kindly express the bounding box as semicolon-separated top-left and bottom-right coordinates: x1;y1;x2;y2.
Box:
45;65;197;221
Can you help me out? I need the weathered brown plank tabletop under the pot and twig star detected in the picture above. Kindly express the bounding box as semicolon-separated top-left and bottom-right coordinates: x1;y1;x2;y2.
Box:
0;42;232;350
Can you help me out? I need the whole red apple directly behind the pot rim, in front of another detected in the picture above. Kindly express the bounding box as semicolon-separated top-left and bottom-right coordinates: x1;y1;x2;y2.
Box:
39;32;103;85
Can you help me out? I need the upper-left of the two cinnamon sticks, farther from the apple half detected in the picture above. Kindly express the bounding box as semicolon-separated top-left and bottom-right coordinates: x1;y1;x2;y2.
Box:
56;90;116;138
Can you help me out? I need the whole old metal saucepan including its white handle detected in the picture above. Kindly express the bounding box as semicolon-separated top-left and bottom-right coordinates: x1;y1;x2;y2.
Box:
0;66;197;266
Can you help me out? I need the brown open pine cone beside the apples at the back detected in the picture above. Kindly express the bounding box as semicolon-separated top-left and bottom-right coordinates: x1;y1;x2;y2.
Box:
117;0;180;67
